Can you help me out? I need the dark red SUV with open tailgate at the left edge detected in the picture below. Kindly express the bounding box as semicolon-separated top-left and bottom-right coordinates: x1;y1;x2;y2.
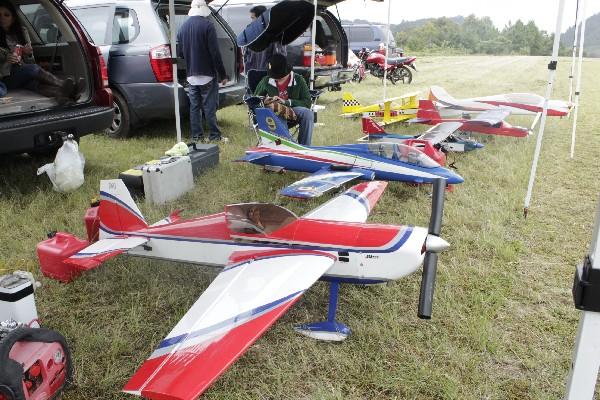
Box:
0;0;112;154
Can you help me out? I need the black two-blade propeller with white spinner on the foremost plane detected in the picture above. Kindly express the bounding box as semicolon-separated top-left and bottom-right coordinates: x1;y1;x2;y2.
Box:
417;178;447;319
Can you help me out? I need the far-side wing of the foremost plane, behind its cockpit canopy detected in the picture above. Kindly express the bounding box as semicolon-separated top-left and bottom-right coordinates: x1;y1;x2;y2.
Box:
303;181;387;222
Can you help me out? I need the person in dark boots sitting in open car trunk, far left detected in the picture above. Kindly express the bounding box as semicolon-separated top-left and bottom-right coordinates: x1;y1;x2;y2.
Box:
0;1;79;104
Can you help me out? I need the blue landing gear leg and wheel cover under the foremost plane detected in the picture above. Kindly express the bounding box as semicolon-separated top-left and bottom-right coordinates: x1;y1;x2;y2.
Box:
294;281;351;342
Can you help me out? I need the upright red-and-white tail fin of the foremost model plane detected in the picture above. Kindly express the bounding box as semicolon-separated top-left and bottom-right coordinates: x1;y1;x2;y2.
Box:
98;179;148;239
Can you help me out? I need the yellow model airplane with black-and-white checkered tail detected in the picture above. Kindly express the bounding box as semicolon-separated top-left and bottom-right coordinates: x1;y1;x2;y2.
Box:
340;92;419;125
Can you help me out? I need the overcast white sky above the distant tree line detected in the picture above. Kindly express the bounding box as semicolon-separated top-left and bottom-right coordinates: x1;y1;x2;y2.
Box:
215;0;600;32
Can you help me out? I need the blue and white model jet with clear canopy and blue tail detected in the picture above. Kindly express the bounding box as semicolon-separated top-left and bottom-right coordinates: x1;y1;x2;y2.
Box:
238;108;463;198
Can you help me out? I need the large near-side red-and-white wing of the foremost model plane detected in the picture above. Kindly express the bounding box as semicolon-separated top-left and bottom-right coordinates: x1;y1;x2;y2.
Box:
123;250;335;400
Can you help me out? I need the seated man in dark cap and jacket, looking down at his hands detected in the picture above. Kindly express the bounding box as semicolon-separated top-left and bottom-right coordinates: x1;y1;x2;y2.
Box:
254;54;314;146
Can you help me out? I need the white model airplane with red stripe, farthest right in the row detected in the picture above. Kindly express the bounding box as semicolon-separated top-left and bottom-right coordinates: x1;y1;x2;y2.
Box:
429;86;571;117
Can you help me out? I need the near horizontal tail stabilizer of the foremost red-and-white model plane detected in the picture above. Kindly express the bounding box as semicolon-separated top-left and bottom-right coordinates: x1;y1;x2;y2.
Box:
65;236;148;270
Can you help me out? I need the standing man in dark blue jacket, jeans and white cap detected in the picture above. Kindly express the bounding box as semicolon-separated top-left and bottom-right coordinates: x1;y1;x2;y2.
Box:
177;0;229;142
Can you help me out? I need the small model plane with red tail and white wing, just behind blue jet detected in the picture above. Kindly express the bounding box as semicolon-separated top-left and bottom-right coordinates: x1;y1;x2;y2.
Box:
359;116;483;154
